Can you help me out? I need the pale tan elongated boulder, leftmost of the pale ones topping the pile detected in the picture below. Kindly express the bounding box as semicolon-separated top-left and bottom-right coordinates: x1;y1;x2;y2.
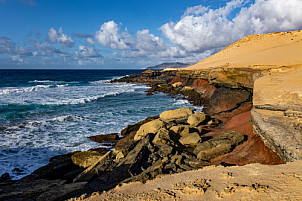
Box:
134;119;165;141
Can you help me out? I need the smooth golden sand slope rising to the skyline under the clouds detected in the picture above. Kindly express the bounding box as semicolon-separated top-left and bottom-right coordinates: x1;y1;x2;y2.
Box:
185;30;302;70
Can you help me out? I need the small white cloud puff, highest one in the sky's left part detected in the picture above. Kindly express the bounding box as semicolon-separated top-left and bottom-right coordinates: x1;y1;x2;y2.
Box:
47;27;75;47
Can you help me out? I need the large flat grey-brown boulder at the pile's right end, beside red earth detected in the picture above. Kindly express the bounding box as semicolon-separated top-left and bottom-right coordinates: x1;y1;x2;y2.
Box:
194;131;244;160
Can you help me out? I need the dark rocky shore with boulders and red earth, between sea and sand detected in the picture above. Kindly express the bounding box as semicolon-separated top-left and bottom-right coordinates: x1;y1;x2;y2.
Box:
0;69;283;200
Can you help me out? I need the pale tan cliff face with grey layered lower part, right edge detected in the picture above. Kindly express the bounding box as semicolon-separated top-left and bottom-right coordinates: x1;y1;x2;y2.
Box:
251;70;302;162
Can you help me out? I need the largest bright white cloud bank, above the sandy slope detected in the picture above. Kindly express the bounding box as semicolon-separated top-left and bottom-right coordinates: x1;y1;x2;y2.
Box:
160;0;302;52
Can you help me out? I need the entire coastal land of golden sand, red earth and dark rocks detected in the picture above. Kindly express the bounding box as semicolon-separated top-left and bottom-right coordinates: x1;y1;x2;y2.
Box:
0;31;302;200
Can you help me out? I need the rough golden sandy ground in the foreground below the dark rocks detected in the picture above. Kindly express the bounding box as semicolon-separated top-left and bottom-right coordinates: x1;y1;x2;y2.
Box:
72;161;302;201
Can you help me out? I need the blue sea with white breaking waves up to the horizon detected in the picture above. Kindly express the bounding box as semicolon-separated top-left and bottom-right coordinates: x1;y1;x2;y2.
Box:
0;69;201;179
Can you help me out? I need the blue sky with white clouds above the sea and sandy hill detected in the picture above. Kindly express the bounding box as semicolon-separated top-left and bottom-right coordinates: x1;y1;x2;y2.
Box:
0;0;302;69
